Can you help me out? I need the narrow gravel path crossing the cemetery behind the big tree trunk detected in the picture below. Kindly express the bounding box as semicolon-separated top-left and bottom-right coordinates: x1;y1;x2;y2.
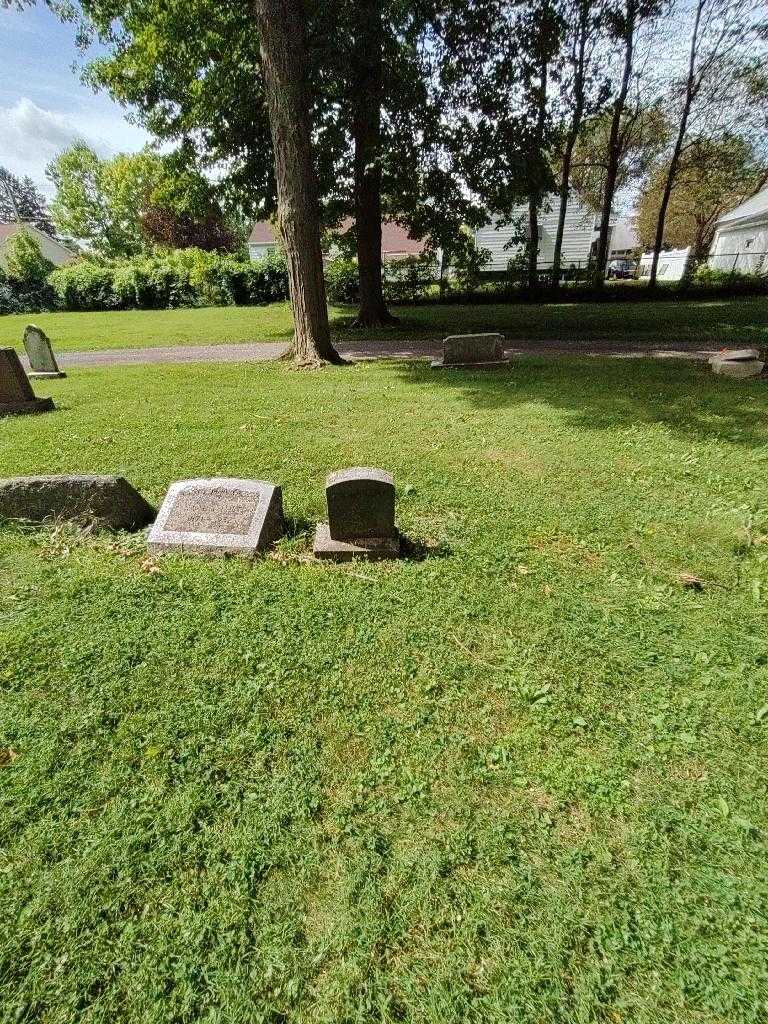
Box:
23;339;717;369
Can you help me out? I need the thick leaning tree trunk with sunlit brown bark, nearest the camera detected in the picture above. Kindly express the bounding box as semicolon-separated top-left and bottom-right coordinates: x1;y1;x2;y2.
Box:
253;0;342;366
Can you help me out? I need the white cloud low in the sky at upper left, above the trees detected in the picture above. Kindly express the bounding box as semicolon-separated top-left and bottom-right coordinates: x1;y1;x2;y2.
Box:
0;96;145;193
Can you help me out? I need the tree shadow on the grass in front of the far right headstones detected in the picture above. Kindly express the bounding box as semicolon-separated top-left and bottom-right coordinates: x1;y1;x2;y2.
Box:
397;356;768;447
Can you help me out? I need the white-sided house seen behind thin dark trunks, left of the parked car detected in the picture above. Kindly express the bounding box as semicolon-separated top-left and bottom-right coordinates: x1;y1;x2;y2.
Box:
475;196;600;271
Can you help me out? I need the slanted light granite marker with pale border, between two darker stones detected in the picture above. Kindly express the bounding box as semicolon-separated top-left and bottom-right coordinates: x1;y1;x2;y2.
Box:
147;476;285;557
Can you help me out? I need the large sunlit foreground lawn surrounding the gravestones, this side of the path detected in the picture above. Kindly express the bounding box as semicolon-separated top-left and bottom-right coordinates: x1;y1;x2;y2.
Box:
0;358;768;1024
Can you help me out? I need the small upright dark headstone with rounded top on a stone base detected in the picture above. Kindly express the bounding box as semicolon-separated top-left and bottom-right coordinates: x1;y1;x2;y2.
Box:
314;466;400;561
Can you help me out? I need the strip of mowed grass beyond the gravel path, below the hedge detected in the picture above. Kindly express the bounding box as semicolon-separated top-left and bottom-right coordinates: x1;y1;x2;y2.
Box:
0;298;768;352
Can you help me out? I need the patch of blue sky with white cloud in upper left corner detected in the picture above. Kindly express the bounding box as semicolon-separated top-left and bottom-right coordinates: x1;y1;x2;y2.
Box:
0;5;147;196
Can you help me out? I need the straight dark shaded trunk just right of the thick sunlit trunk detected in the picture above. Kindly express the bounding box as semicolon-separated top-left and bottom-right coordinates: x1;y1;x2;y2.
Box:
352;0;394;327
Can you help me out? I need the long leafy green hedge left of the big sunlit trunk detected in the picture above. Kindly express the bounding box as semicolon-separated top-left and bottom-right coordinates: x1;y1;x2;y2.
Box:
49;249;288;310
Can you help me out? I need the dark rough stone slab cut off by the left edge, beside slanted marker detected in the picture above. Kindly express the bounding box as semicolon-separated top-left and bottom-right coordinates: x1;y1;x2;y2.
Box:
0;474;155;529
